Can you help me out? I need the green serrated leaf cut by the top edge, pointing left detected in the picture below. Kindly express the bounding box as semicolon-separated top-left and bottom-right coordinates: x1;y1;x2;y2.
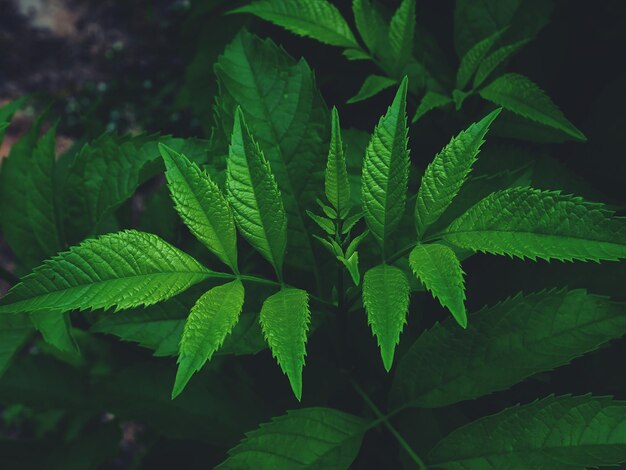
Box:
231;0;359;49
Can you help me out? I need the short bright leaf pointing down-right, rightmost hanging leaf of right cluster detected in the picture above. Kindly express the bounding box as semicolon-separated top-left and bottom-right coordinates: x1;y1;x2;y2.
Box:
409;243;467;328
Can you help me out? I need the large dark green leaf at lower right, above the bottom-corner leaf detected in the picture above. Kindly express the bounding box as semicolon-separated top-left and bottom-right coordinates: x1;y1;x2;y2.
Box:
392;289;626;408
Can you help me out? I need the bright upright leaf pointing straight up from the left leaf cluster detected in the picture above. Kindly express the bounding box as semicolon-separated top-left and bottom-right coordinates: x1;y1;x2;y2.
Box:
226;108;287;278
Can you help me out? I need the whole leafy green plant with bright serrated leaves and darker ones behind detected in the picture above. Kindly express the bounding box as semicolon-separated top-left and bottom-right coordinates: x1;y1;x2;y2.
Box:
0;0;626;469
